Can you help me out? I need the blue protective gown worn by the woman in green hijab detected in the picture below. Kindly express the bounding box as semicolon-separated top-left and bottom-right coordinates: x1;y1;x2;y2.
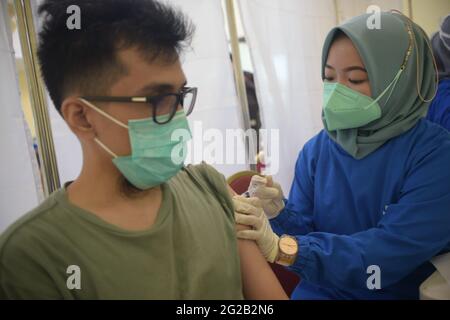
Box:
271;119;450;299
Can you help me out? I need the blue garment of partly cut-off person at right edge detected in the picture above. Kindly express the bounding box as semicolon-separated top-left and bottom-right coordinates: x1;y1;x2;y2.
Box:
427;78;450;131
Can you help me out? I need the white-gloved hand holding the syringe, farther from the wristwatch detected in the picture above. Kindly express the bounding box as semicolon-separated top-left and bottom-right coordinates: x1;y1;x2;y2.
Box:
247;175;284;219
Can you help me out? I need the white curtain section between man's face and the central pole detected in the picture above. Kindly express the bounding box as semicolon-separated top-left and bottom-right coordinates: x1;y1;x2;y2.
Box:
166;0;249;176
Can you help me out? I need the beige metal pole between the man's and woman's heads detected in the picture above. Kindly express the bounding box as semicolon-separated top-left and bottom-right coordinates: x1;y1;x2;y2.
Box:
225;0;257;170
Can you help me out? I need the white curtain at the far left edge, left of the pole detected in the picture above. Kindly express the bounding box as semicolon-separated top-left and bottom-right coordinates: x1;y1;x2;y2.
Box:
0;0;42;232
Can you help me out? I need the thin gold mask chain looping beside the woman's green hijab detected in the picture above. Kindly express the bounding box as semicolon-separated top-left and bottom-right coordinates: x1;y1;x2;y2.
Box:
391;9;439;103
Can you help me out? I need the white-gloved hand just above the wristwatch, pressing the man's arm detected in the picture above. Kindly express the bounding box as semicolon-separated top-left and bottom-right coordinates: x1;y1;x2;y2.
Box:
233;196;279;262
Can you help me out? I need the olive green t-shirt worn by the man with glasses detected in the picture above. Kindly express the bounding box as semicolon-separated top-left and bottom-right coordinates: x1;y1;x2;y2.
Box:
0;164;243;299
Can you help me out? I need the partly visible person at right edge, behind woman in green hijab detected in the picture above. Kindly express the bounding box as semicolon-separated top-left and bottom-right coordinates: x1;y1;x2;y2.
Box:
427;15;450;131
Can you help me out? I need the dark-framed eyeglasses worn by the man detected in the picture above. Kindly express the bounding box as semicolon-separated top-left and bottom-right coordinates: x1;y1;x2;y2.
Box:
81;88;197;124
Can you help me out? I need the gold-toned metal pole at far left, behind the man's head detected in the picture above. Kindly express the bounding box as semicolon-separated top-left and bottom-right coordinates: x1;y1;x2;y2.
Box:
14;0;60;196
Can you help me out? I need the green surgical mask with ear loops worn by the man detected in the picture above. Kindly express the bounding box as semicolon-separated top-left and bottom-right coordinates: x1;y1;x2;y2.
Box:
81;99;191;190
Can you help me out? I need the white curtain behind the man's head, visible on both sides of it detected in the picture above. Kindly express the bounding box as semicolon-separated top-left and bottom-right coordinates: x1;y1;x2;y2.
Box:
40;0;248;182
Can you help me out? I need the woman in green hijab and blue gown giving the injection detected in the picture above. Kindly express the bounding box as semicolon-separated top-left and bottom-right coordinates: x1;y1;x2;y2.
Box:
234;12;450;299
